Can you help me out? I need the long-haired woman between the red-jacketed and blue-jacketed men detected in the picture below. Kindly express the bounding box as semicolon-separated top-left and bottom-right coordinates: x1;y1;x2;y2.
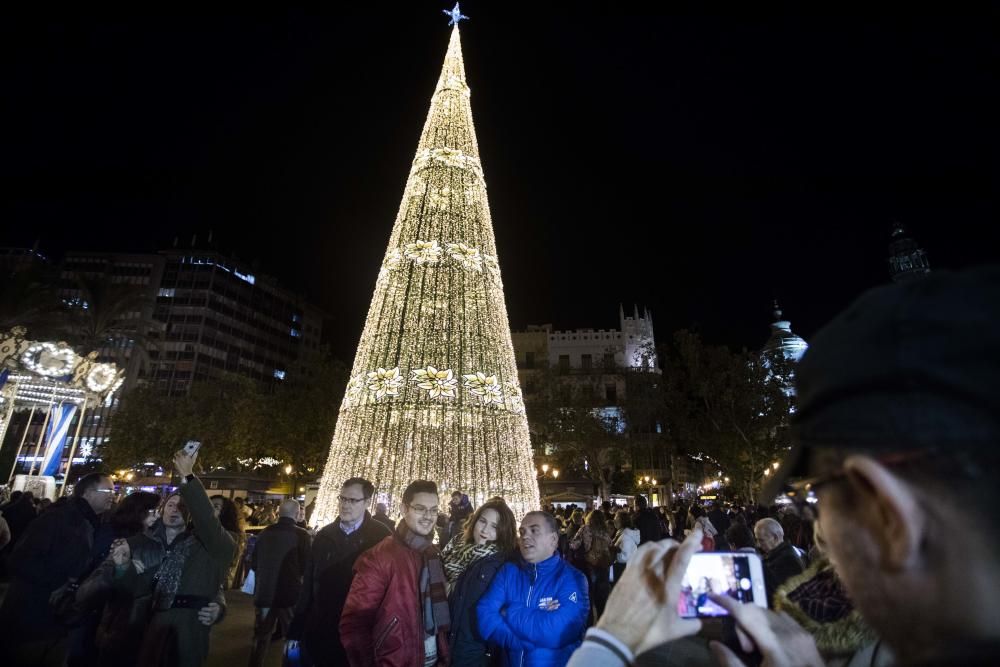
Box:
441;499;517;667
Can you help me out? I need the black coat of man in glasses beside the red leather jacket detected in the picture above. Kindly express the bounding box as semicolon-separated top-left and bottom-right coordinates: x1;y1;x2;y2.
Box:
287;512;392;667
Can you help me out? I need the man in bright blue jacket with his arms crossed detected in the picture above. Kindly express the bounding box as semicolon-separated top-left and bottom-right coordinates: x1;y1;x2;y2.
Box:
476;512;590;667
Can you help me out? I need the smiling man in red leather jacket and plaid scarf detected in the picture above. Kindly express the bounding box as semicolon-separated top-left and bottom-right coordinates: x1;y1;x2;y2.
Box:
340;480;450;667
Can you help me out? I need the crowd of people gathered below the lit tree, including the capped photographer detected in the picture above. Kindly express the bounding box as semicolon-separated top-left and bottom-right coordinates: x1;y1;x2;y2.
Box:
0;269;1000;667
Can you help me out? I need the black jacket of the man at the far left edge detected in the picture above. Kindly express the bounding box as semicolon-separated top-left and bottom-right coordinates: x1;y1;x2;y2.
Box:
0;498;98;643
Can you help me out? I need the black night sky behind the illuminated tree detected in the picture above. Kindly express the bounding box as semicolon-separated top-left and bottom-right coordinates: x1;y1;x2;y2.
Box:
0;0;1000;360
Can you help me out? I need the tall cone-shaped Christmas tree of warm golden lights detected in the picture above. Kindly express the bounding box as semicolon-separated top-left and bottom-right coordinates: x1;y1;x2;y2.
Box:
313;25;539;525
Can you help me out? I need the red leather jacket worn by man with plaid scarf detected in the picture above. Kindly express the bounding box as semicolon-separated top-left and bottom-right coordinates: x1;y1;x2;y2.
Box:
340;535;448;667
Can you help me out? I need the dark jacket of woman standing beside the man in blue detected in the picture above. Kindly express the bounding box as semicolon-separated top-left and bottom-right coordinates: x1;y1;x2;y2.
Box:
448;554;504;667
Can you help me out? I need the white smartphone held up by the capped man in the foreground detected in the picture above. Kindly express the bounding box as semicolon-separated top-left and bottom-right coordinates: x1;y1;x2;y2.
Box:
677;551;767;618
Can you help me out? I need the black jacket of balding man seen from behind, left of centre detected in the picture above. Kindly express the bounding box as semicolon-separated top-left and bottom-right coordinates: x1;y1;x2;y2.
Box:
250;516;312;608
